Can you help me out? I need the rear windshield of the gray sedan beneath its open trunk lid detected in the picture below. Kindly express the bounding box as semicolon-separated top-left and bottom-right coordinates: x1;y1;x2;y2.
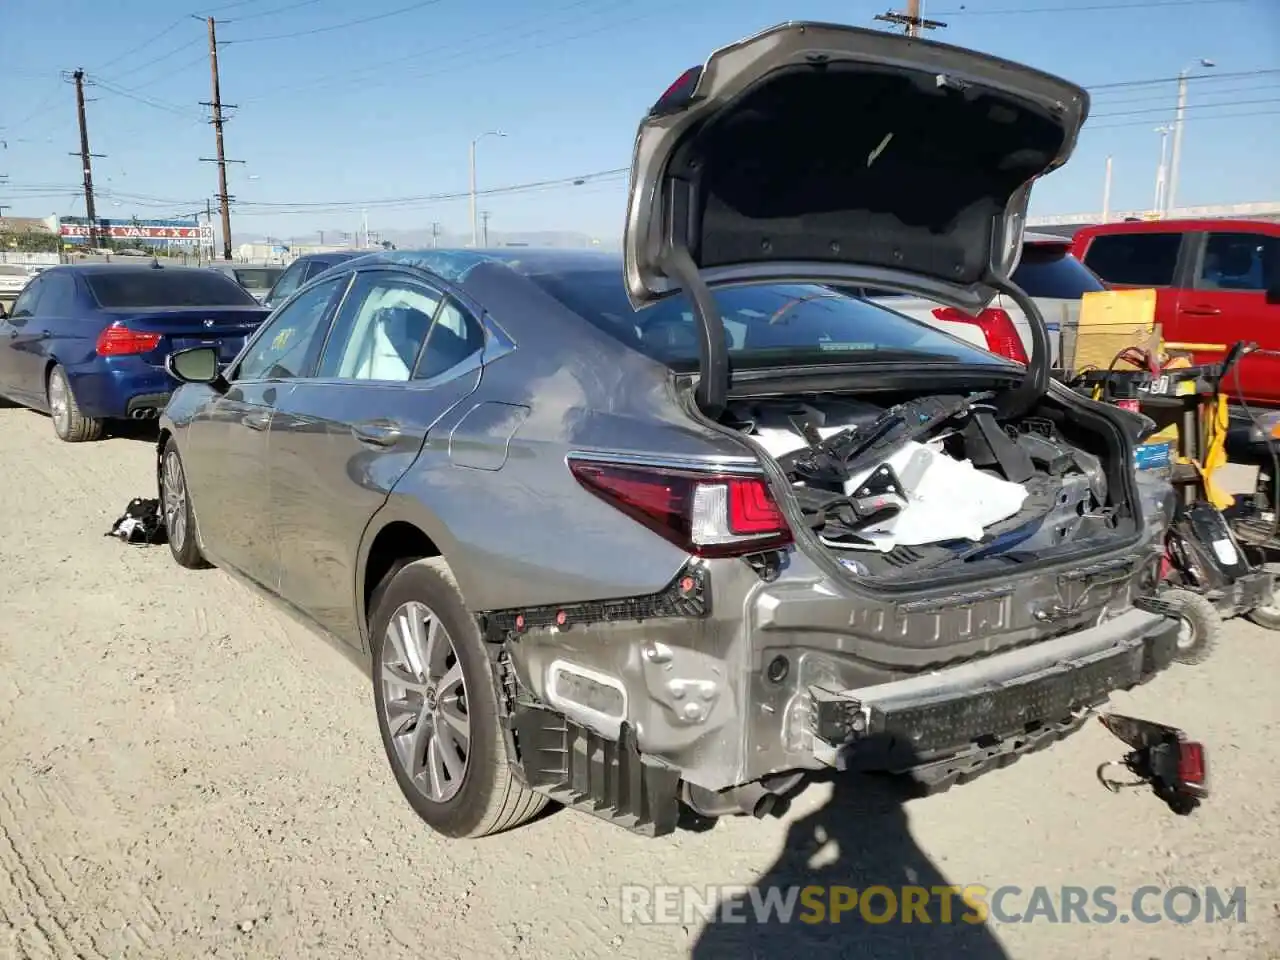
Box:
530;270;1005;367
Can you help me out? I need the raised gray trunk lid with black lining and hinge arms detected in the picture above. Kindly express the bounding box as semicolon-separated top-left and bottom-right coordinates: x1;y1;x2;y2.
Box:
623;22;1089;416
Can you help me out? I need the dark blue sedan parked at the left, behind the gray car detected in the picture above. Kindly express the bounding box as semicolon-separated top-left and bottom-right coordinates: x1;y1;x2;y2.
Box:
0;261;270;443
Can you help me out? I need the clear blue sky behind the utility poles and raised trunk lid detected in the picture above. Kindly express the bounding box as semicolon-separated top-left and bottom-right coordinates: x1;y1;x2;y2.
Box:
0;0;1280;239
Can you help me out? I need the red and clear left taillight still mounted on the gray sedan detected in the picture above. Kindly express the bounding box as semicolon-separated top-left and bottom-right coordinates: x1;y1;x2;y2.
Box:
570;460;791;557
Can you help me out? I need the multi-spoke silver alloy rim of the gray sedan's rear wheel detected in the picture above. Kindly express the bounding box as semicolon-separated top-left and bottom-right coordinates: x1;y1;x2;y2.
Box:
379;600;471;804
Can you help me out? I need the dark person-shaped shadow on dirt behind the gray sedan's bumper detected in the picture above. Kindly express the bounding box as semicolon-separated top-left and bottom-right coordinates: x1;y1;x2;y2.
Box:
690;773;1009;960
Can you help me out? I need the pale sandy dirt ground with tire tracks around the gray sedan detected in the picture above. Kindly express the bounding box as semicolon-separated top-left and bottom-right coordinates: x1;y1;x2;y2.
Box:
0;410;1280;960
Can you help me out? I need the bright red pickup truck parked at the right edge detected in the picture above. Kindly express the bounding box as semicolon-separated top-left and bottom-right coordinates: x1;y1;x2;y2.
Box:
1071;220;1280;410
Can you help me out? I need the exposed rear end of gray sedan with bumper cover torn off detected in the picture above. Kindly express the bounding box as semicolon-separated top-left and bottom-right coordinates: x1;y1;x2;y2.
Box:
484;562;1178;836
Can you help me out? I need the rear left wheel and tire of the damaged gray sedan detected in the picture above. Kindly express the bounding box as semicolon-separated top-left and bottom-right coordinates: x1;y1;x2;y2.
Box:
369;558;547;838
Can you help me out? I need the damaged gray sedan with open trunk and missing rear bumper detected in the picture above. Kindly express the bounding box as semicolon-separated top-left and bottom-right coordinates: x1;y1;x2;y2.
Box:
157;23;1178;837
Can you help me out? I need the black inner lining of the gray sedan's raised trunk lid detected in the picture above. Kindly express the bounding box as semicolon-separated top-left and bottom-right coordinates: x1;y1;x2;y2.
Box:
669;63;1066;284
